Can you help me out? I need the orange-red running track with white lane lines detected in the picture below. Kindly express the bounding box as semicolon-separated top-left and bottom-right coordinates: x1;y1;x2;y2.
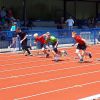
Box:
0;46;100;100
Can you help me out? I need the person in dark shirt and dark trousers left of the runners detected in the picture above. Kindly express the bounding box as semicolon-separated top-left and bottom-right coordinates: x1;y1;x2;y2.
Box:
16;28;32;56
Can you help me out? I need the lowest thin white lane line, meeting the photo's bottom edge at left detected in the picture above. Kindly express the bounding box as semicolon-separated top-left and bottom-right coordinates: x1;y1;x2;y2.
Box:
14;80;100;100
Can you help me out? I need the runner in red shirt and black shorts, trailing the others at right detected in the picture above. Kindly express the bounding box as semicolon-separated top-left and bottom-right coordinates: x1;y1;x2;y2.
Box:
72;32;92;62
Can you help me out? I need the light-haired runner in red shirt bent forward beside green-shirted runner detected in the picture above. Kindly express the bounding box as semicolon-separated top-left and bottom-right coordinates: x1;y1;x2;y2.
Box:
34;33;49;58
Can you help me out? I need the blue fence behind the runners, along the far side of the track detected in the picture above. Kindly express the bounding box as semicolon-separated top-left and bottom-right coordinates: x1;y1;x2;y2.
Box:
0;28;100;52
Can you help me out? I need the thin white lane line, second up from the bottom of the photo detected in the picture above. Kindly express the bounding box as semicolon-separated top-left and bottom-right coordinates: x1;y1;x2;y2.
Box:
0;70;100;91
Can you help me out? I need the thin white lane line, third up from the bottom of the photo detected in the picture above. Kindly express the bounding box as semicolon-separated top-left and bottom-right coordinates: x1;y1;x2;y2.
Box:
0;63;100;80
